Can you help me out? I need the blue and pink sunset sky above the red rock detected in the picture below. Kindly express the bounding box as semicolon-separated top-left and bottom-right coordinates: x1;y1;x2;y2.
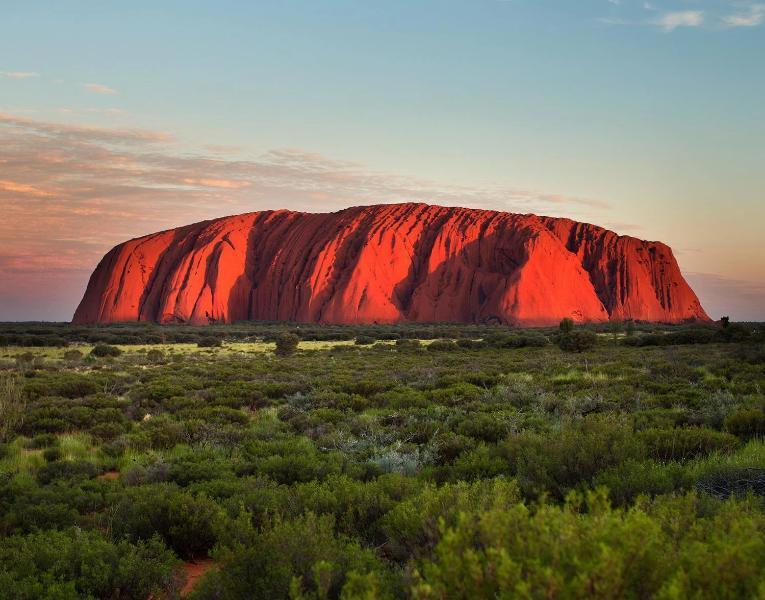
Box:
0;0;765;321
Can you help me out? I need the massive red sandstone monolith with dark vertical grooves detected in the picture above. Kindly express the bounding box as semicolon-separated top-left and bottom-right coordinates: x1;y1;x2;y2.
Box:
74;204;708;326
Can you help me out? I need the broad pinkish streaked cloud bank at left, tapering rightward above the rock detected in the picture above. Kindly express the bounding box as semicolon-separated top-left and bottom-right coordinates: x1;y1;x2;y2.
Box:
0;113;608;319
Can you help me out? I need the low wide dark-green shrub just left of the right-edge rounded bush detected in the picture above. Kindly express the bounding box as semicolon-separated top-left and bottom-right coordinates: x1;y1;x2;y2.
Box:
638;427;739;460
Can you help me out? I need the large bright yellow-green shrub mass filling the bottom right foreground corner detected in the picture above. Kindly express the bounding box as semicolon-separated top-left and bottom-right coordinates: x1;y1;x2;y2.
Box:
412;491;765;599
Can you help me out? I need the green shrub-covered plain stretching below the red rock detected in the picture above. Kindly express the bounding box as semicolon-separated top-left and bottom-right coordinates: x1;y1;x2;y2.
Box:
0;322;765;600
